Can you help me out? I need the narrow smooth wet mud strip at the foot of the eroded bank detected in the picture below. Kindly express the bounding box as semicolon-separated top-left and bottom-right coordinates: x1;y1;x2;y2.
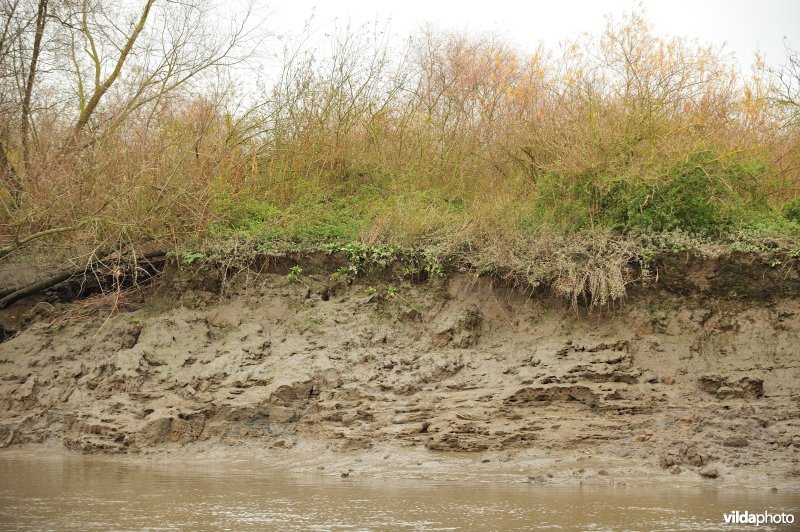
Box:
0;440;800;492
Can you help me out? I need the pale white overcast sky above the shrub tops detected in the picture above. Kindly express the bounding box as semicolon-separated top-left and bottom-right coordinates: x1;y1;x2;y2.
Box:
257;0;800;66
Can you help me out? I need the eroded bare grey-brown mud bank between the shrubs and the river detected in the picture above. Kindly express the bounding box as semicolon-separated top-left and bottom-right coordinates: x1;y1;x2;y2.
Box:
0;256;800;489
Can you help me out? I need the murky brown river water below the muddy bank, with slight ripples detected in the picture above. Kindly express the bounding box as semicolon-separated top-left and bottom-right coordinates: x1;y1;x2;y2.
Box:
0;453;800;530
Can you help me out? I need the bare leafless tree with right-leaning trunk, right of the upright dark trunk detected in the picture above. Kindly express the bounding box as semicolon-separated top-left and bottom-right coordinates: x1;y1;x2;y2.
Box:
71;0;260;145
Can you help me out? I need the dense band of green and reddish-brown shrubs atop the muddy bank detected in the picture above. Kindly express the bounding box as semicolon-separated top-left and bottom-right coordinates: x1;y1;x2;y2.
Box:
0;1;800;304
